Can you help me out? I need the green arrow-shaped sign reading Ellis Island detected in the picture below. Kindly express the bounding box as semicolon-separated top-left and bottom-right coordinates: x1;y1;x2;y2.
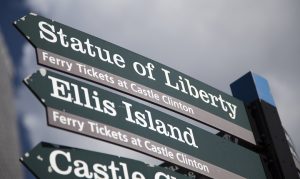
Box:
24;69;265;179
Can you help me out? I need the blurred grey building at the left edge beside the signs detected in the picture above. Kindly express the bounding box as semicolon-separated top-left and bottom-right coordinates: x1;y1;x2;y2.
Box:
0;31;23;179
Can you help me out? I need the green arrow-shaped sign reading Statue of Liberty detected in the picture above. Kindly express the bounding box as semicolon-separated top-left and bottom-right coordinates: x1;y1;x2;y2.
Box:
15;13;255;144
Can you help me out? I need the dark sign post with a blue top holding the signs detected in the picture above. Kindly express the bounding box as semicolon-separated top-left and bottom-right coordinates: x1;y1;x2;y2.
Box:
231;72;299;179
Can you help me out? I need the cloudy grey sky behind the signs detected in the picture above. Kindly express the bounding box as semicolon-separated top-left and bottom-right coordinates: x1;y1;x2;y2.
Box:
0;0;300;178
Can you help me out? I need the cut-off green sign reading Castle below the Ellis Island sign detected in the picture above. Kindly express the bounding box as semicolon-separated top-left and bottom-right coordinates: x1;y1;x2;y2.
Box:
20;142;192;179
